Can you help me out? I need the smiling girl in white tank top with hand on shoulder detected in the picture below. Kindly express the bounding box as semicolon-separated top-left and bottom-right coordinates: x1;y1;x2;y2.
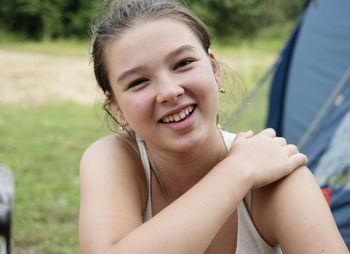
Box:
79;0;348;254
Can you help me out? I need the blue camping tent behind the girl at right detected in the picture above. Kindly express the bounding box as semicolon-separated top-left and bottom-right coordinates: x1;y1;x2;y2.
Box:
267;0;350;248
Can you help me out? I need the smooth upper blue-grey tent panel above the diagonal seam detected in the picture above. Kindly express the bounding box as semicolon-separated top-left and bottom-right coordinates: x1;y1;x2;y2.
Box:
281;0;350;147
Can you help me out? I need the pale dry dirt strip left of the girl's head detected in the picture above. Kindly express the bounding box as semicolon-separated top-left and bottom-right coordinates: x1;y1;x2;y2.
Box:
0;50;103;106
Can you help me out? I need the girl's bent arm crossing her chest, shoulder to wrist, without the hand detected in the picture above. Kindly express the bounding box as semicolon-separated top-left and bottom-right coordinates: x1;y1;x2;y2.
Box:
79;136;249;254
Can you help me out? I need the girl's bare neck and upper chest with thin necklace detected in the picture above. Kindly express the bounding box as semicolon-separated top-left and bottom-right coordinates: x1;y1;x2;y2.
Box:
147;129;227;200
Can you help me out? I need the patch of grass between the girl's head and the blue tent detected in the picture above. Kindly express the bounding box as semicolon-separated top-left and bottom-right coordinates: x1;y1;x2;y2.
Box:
213;39;283;133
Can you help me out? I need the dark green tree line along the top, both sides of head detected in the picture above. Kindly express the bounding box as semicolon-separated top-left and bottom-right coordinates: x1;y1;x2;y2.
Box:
0;0;305;40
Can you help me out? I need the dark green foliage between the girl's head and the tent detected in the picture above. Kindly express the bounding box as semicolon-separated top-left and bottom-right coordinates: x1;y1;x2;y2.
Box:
188;0;305;42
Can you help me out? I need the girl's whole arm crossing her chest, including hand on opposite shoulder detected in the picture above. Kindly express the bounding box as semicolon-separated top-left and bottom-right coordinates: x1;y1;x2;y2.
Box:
80;132;306;254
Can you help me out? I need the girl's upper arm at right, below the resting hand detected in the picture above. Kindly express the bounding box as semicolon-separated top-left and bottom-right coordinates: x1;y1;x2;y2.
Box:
253;167;349;254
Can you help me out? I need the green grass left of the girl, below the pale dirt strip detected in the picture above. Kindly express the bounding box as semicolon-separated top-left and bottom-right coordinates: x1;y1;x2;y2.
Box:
0;103;108;253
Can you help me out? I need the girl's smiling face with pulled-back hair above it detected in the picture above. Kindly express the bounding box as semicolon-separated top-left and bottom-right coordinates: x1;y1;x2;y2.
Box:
106;19;220;152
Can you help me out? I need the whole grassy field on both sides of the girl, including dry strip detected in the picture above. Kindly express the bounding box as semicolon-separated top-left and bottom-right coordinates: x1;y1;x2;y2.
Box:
0;38;281;254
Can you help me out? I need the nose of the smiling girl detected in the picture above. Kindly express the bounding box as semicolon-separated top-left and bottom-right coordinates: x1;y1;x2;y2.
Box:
157;78;185;104
